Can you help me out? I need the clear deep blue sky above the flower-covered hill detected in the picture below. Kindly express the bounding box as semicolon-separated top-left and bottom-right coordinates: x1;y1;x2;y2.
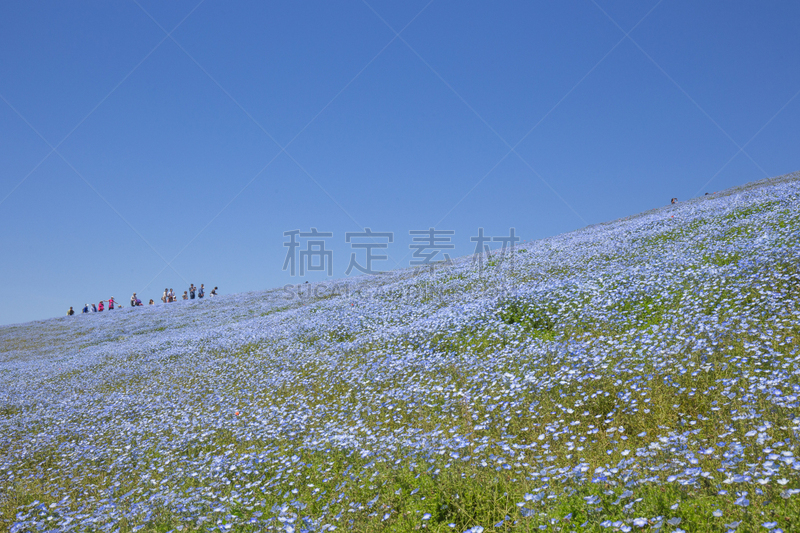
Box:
0;0;800;324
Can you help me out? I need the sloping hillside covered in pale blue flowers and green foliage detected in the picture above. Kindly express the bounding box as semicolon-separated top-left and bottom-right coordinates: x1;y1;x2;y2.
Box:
0;174;800;532
